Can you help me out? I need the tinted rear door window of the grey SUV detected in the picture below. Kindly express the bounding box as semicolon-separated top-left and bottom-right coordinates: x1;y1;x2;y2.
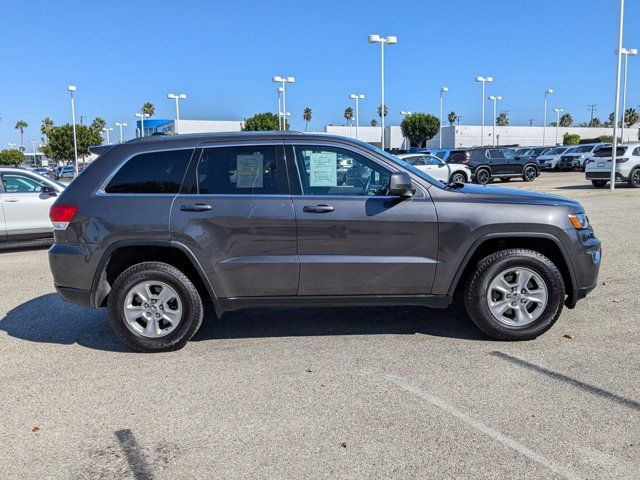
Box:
197;145;288;195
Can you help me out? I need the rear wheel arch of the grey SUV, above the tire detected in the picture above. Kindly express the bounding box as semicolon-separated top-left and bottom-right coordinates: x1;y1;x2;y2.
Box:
91;240;218;311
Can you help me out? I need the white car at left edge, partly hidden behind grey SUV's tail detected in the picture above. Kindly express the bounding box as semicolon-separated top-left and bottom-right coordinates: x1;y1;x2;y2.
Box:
0;167;65;246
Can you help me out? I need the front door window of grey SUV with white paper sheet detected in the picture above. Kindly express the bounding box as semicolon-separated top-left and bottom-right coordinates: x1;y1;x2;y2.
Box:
294;145;391;195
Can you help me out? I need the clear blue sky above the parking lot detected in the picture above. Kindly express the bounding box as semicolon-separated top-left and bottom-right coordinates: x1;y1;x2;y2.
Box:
0;0;640;148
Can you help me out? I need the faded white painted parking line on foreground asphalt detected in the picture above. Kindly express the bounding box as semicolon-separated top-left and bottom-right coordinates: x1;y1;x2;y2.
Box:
386;374;582;480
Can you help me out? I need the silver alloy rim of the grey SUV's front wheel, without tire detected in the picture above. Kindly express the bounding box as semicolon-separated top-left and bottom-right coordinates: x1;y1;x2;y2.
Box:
486;267;549;327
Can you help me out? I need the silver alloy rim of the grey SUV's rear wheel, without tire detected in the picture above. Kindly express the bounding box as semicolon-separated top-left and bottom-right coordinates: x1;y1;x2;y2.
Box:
123;281;183;338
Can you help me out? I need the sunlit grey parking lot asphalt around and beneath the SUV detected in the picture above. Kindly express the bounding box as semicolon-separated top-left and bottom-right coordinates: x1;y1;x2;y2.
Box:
0;172;640;480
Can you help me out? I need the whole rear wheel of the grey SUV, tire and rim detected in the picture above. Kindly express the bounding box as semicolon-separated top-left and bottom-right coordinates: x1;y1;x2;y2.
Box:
108;262;203;352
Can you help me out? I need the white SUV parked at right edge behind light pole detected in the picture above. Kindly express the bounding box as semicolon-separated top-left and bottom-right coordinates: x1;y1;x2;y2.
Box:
585;143;640;188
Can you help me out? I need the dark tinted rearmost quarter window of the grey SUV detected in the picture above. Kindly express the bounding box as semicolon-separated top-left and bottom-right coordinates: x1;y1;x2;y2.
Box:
104;149;193;194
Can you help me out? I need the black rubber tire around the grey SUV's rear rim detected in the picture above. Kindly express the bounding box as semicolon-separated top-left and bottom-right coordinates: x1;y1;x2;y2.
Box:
107;262;203;352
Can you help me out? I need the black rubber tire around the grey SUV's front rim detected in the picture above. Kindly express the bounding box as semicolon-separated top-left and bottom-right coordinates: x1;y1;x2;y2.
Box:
464;248;565;341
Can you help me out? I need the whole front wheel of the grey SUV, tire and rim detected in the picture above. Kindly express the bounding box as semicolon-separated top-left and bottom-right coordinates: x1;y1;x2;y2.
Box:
464;248;565;340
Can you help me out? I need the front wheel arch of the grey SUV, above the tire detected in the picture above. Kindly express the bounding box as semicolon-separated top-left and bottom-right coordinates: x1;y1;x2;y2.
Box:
448;232;577;307
